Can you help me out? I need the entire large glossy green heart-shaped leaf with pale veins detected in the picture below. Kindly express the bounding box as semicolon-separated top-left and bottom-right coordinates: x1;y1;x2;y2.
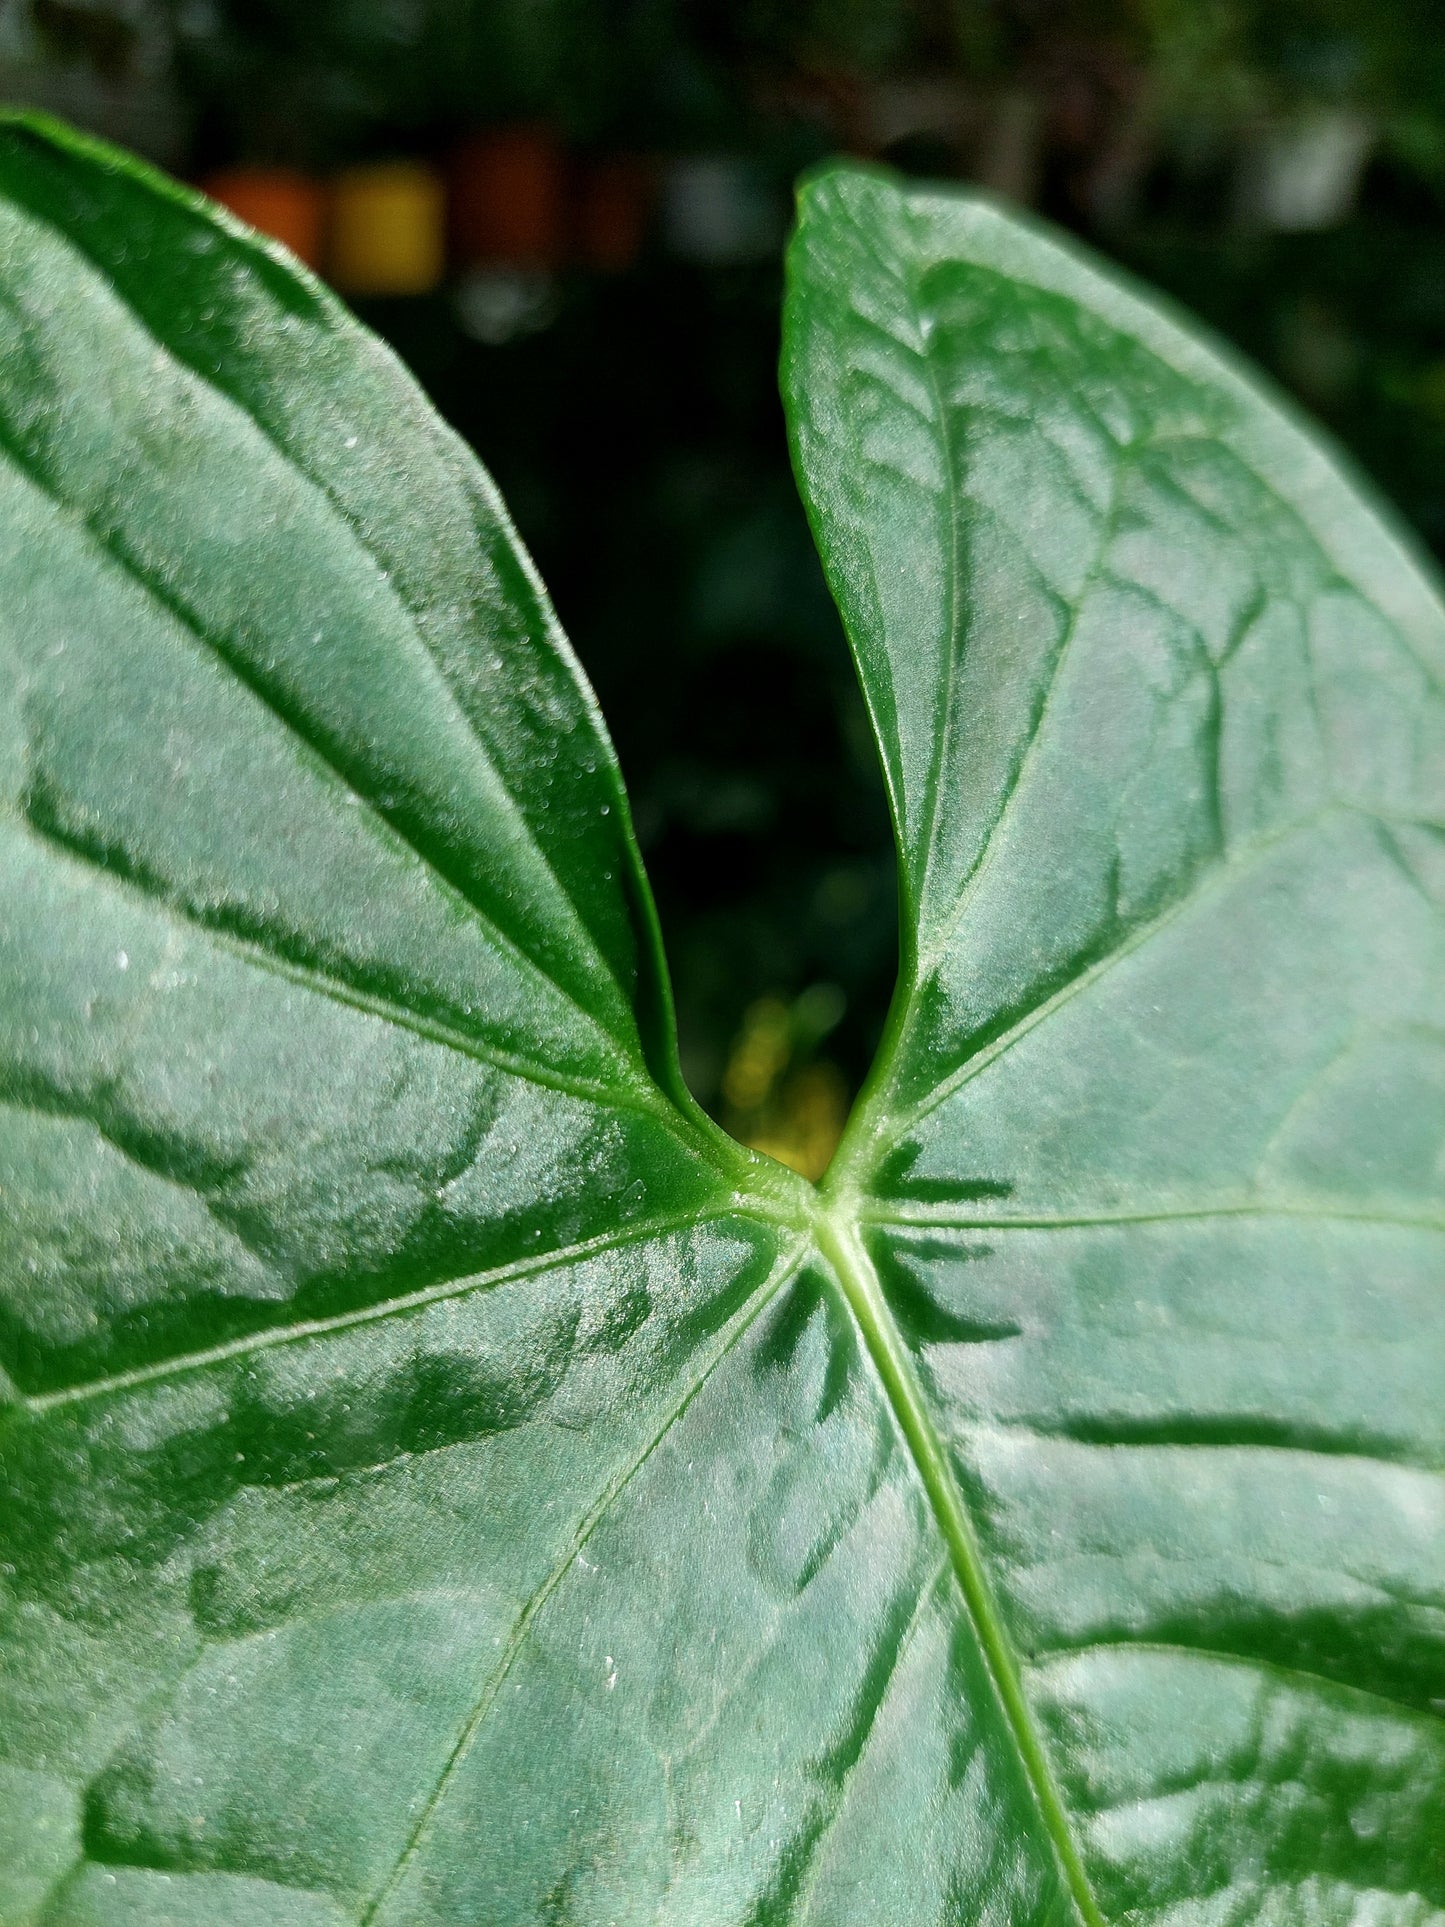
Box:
0;123;1445;1927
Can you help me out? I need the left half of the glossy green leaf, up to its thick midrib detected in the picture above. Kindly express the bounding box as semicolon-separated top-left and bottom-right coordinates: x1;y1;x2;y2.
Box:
0;123;1069;1927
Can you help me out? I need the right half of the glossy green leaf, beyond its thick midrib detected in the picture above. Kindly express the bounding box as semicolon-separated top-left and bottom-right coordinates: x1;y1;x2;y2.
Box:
784;172;1445;1923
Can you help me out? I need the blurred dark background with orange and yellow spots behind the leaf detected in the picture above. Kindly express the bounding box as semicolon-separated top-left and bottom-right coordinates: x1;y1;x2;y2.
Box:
0;0;1445;1170
